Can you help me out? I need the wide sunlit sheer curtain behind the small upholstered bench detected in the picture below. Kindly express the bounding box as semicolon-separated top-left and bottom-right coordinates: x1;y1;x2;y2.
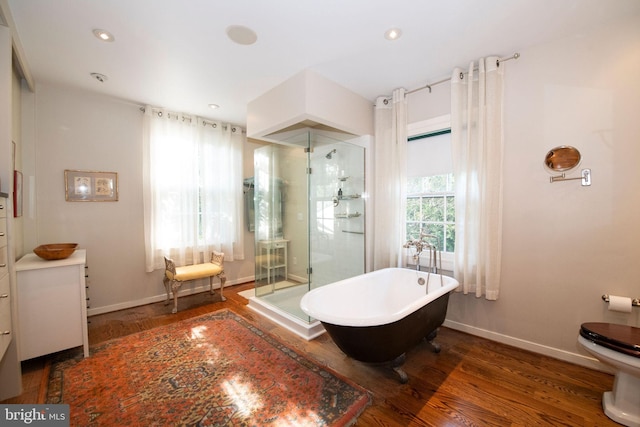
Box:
143;107;245;272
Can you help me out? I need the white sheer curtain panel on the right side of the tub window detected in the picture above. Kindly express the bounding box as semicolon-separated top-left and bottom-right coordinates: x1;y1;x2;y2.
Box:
451;57;504;300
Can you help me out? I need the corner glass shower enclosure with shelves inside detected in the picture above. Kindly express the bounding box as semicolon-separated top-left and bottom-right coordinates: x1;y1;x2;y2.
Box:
253;130;366;322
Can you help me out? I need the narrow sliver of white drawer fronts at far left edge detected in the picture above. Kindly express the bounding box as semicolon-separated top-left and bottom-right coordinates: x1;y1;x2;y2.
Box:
0;197;13;360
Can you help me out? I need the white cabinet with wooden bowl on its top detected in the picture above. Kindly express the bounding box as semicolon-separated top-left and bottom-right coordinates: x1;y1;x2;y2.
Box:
16;249;89;360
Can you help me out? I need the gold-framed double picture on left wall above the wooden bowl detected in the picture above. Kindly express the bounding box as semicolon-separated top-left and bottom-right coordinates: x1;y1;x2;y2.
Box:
64;169;118;202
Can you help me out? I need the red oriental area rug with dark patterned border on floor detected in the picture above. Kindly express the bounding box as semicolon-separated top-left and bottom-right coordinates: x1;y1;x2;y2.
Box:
46;310;371;427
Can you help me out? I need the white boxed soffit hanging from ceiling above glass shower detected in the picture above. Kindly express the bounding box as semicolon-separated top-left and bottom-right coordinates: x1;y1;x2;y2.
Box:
247;70;373;142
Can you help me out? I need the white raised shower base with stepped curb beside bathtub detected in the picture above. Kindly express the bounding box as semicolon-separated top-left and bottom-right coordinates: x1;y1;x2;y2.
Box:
239;286;325;341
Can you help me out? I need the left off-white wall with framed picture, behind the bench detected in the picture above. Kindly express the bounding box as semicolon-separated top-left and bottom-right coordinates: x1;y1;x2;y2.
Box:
18;85;254;314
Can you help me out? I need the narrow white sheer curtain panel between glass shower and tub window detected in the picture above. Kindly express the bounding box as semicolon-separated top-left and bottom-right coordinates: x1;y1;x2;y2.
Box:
373;89;407;270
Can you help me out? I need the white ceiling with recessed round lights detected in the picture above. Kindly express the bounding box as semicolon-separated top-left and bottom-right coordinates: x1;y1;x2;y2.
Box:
6;0;640;125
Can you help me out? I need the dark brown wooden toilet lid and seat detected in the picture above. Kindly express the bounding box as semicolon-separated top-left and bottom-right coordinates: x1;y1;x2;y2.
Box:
580;322;640;357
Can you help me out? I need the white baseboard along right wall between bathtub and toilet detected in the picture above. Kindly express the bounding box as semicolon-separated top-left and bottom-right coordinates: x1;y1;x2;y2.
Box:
443;320;613;373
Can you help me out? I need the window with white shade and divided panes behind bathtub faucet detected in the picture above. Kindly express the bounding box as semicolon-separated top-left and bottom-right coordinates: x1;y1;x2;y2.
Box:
406;116;455;270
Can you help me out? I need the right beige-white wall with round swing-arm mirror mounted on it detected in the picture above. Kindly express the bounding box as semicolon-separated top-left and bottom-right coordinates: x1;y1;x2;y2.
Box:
409;16;640;365
